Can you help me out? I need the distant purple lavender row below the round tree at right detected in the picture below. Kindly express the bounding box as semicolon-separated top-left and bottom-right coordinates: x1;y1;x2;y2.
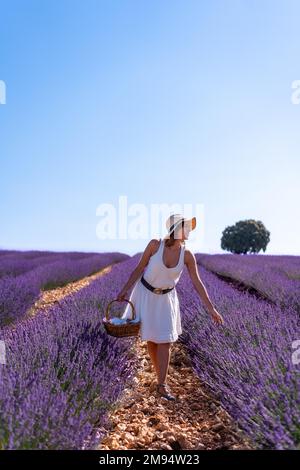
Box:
196;253;300;313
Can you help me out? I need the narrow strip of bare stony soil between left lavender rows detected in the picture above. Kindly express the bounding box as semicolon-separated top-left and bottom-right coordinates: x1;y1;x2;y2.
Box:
27;264;113;316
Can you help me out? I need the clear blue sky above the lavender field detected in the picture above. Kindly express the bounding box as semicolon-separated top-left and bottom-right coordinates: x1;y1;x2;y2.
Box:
0;0;300;254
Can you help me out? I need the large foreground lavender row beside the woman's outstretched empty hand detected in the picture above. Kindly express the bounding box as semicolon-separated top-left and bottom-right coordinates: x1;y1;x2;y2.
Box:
178;266;300;449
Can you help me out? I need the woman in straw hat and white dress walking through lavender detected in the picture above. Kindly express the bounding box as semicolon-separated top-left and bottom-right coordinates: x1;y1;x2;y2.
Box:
117;214;224;400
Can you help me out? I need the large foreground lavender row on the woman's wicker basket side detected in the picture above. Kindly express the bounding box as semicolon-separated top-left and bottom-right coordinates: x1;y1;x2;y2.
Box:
0;257;141;449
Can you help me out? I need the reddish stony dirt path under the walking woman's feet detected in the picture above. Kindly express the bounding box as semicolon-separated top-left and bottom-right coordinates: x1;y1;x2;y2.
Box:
97;337;253;450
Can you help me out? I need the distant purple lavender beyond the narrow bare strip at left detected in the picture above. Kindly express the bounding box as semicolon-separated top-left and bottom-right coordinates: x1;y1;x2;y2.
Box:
0;252;129;326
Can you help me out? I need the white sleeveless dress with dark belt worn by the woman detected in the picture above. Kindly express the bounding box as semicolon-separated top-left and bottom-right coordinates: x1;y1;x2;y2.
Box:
121;239;185;343
